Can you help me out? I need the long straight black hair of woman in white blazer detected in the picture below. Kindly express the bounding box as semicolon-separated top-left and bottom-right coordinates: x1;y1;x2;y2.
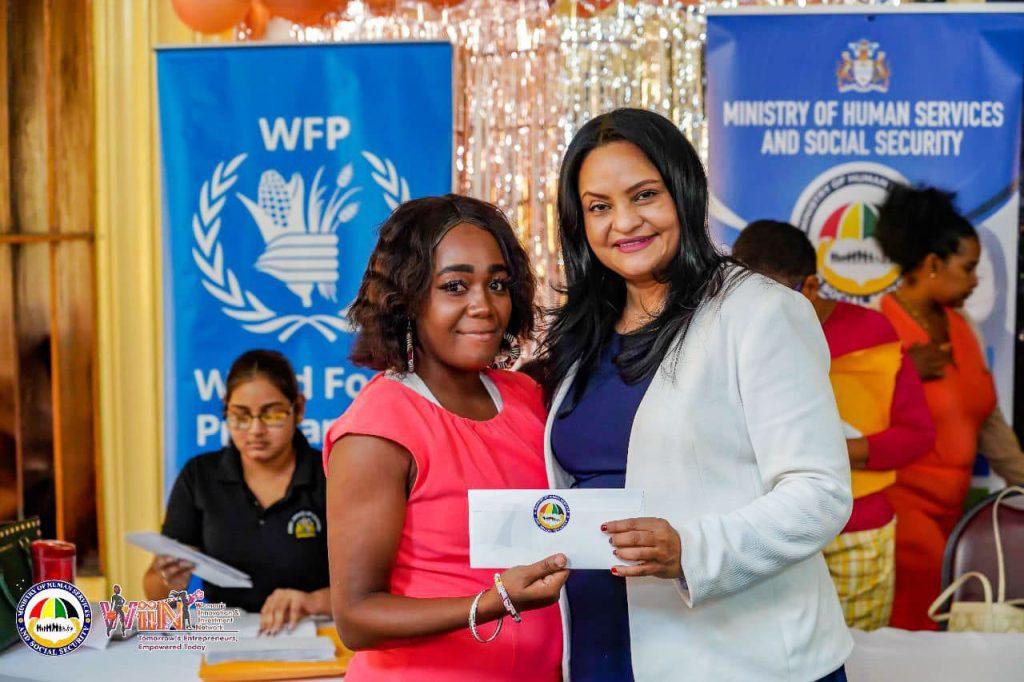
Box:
542;109;731;410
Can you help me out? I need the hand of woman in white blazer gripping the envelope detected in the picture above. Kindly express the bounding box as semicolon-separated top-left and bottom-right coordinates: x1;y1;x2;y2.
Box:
601;518;683;578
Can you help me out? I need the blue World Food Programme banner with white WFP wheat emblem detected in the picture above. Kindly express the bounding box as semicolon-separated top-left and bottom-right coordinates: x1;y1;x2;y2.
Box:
157;43;453;489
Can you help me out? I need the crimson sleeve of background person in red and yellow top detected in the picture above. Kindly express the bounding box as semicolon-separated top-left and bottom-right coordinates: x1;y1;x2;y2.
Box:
864;353;935;470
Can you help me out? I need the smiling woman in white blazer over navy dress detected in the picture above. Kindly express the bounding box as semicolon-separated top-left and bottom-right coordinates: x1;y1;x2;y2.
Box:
542;109;853;682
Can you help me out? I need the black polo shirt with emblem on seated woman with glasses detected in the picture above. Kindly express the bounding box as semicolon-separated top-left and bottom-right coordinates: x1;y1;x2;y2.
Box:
163;431;330;611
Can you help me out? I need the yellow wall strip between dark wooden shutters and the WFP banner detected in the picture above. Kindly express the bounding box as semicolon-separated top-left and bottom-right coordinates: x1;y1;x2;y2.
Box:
91;0;230;599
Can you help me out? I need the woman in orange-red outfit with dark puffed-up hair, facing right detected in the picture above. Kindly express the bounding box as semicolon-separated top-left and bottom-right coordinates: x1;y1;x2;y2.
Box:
876;186;1024;630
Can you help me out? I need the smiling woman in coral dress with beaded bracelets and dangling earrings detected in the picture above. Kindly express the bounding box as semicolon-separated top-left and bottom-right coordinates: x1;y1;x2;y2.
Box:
324;195;568;682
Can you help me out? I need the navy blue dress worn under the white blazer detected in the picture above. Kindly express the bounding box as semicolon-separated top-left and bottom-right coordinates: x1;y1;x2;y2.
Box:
551;334;650;682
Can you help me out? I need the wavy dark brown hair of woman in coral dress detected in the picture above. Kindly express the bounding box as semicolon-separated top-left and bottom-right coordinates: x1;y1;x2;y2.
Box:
348;195;536;372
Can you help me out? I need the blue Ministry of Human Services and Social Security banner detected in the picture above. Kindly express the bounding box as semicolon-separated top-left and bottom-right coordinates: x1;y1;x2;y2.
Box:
707;6;1024;415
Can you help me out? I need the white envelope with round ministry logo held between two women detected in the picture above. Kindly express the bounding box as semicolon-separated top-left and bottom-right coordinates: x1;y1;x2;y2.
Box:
469;488;643;569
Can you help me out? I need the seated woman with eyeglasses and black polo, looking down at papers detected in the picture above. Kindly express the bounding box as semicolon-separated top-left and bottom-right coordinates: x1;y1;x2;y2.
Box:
144;350;331;634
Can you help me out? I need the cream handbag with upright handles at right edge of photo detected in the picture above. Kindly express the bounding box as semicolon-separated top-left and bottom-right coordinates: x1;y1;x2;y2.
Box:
928;485;1024;633
